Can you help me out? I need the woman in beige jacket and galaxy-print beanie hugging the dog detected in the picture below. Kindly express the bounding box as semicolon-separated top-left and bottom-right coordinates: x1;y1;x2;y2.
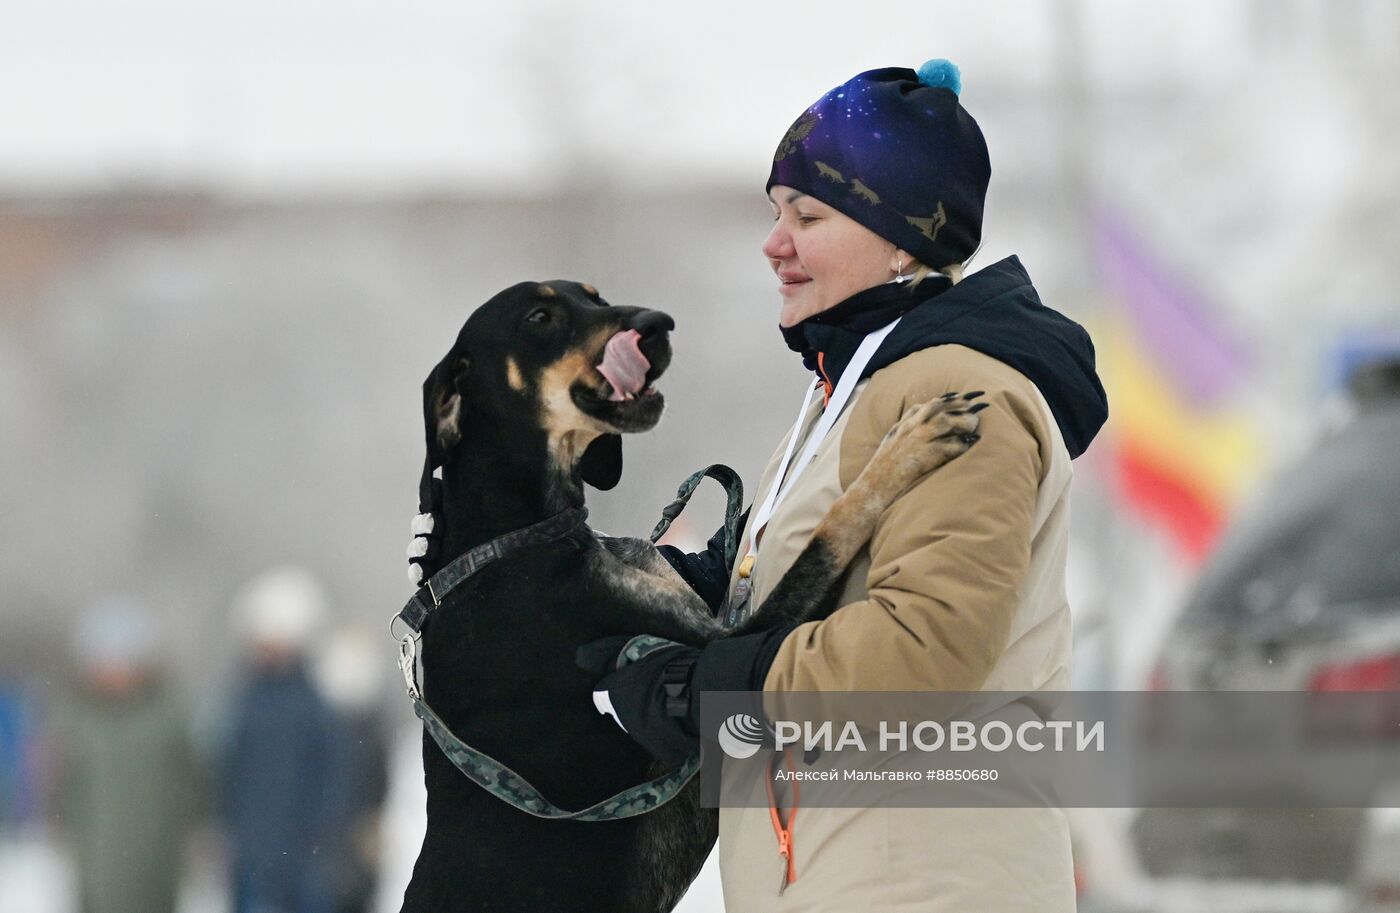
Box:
576;60;1107;913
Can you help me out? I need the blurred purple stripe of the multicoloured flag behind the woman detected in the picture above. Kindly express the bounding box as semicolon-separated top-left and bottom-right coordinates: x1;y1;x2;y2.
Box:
1093;209;1249;406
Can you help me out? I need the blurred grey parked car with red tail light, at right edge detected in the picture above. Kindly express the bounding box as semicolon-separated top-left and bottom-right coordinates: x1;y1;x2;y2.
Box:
1130;361;1400;913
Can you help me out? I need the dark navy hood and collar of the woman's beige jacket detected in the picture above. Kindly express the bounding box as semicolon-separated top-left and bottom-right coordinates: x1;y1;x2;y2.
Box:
783;256;1109;458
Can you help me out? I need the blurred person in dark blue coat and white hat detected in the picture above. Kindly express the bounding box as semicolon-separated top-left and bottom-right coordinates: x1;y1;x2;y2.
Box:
223;567;346;913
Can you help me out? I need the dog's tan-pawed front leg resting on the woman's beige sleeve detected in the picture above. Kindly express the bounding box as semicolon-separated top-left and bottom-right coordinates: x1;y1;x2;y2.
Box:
735;391;986;634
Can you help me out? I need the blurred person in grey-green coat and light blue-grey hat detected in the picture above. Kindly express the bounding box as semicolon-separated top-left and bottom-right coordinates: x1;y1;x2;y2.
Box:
55;597;202;913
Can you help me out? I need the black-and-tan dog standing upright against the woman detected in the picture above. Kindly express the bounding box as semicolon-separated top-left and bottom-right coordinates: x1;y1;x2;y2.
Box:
403;281;977;913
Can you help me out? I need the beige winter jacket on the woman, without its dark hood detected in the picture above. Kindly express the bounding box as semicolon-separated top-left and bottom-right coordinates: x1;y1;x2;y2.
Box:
720;344;1075;913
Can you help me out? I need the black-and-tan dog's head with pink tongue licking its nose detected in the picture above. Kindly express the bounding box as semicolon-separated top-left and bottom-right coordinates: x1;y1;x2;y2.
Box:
423;280;675;504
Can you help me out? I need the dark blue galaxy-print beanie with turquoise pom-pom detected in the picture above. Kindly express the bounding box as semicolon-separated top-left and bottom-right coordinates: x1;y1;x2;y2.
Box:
766;60;991;269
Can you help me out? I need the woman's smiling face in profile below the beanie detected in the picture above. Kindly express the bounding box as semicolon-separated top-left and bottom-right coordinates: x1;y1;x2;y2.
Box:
763;183;909;326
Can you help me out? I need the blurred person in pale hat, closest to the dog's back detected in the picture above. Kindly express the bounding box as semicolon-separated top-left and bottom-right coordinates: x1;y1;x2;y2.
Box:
315;626;389;913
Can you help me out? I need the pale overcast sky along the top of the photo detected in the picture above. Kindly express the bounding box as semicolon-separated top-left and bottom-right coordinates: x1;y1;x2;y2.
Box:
0;0;1304;192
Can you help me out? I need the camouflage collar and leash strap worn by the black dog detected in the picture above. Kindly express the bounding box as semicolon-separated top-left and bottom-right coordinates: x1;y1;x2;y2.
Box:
395;464;743;821
